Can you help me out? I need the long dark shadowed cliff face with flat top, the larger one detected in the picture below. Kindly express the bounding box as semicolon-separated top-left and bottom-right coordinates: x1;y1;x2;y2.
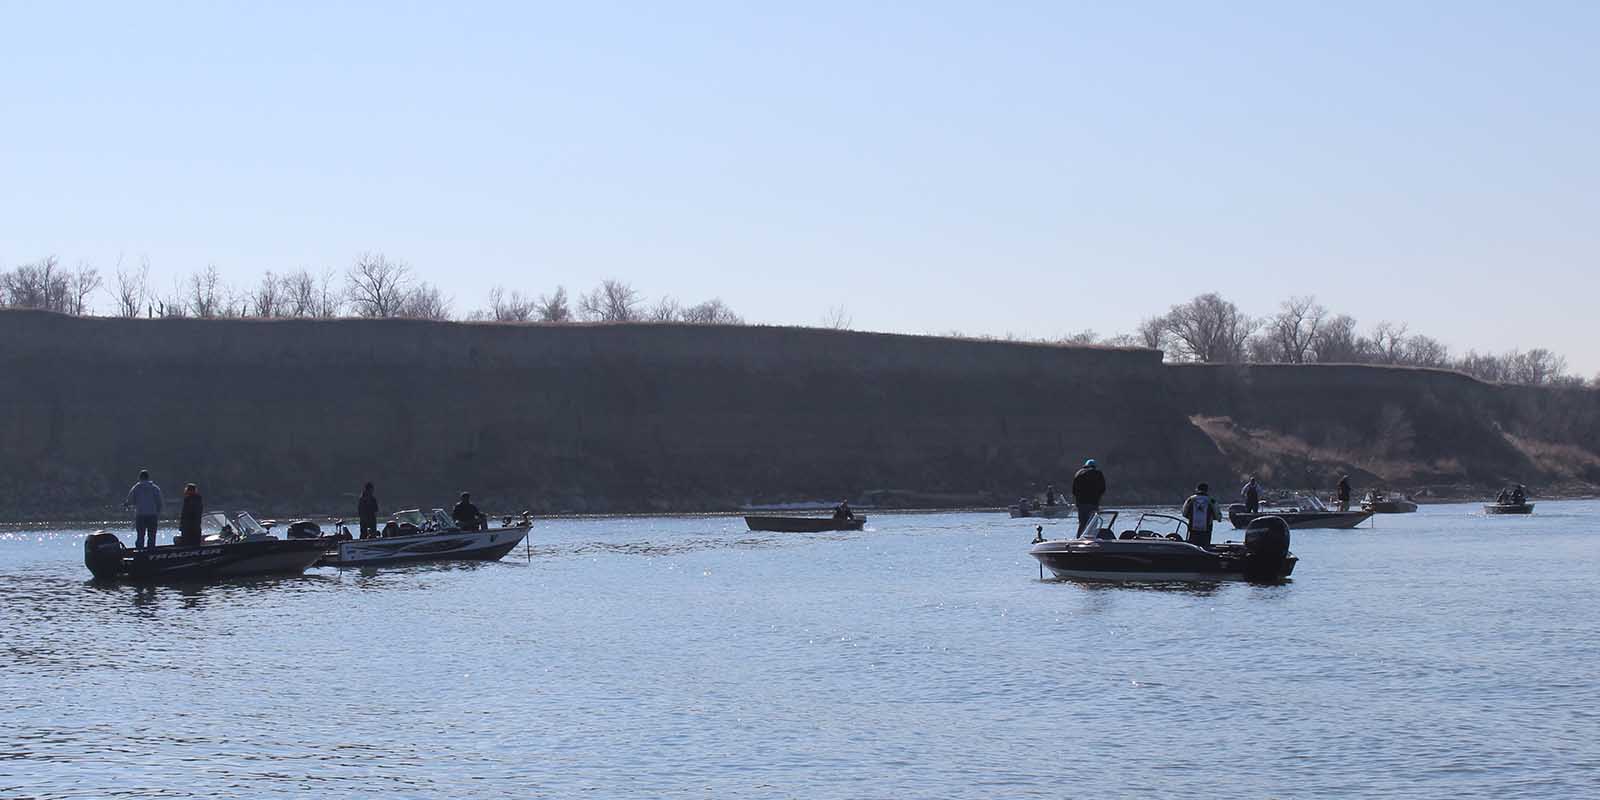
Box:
0;312;1229;518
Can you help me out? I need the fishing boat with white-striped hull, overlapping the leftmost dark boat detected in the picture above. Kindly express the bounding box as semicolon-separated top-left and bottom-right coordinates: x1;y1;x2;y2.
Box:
317;509;533;566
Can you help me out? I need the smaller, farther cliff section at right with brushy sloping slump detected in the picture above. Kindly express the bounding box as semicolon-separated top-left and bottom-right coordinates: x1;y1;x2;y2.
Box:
1168;365;1600;494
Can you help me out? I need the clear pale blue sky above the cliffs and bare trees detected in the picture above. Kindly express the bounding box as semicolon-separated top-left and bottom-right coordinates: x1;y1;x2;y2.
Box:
0;0;1600;376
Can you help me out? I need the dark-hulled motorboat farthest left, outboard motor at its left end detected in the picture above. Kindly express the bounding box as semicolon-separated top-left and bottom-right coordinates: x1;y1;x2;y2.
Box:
83;531;328;582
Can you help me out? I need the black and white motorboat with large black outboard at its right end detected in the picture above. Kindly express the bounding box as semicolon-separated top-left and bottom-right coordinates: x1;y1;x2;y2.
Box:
1029;512;1299;581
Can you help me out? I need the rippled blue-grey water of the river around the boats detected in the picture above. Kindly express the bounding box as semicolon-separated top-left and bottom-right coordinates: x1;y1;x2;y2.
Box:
0;501;1600;798
